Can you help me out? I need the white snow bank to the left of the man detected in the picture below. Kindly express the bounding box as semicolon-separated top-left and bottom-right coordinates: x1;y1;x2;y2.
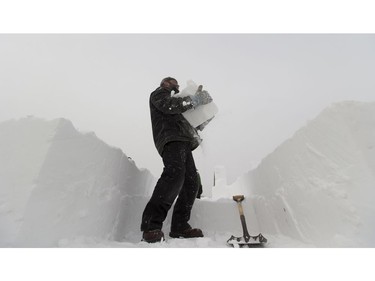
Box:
0;118;155;247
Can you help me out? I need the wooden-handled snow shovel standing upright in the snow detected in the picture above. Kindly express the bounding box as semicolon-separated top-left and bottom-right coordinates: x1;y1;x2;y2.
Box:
227;195;267;248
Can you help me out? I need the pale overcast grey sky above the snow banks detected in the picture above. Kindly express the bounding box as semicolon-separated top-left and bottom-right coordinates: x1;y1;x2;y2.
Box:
0;34;375;182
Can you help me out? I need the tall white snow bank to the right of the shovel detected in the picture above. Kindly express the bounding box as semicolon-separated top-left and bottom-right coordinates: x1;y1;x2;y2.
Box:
226;102;375;247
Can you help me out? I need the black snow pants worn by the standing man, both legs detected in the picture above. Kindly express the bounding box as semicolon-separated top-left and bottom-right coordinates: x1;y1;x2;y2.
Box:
141;141;198;232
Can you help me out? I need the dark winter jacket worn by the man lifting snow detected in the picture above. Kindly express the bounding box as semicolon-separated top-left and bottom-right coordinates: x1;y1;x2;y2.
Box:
150;87;200;156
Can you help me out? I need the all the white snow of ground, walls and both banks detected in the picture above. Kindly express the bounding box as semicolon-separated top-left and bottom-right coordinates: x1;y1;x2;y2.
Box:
0;102;375;245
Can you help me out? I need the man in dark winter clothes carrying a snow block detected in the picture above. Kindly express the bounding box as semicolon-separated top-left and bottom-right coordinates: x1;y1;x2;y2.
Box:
141;77;212;243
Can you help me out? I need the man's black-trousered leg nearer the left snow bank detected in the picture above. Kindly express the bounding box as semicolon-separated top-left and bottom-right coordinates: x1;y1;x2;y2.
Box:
141;142;191;231
